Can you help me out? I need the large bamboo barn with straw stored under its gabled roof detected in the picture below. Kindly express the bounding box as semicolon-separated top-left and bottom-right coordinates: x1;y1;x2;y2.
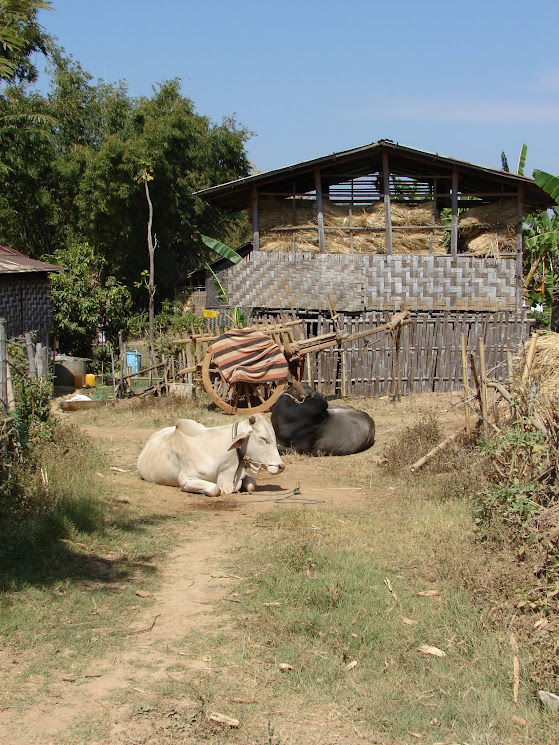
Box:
197;140;553;396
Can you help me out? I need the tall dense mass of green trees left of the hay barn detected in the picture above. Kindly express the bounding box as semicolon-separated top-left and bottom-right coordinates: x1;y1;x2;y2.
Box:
0;50;250;306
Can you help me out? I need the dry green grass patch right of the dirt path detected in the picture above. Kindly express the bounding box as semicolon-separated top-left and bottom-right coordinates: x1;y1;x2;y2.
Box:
224;504;559;743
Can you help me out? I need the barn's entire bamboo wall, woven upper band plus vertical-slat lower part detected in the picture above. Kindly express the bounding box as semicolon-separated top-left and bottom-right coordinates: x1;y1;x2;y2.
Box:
206;251;530;396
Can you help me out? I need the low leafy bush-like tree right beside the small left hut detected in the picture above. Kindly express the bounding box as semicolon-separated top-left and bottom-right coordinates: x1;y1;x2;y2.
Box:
48;238;132;357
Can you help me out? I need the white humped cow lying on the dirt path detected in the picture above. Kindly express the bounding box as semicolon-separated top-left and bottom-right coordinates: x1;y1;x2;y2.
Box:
138;415;285;497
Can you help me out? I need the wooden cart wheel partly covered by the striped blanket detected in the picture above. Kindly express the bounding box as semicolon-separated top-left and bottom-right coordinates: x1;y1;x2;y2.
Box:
202;352;287;415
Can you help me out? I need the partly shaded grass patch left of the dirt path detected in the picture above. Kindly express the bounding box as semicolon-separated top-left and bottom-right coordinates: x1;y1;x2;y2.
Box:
0;416;187;708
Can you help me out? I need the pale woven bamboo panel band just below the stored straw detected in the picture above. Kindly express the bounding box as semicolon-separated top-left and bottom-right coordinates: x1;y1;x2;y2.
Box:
210;251;518;312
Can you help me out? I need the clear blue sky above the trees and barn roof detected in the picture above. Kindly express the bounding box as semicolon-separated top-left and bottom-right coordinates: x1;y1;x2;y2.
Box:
40;0;559;175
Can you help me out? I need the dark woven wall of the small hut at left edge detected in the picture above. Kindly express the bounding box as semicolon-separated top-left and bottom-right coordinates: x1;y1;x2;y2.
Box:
0;272;52;344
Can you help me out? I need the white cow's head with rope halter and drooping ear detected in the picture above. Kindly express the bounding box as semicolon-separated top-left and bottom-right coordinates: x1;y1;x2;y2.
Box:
229;414;285;474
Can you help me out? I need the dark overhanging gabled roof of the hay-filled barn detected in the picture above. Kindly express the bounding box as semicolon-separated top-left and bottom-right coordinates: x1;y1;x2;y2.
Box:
195;140;555;212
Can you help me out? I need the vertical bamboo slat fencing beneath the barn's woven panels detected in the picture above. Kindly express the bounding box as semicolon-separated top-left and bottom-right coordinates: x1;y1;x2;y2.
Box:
254;311;530;397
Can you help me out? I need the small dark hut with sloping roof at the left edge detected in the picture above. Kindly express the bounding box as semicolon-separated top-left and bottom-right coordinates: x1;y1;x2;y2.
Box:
0;244;64;345
